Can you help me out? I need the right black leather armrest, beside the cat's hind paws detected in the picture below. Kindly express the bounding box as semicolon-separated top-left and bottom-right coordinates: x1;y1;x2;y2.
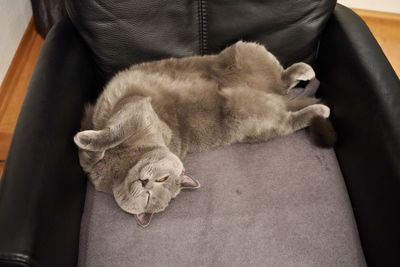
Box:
317;5;400;266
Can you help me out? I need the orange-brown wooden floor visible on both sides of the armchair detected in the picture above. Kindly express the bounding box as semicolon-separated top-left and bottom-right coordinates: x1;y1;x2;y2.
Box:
0;10;400;179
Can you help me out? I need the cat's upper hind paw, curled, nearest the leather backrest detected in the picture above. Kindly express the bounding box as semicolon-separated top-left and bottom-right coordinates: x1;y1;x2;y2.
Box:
282;62;315;90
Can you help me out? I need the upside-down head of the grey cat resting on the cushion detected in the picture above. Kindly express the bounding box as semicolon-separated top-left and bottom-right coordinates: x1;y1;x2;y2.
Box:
113;149;200;226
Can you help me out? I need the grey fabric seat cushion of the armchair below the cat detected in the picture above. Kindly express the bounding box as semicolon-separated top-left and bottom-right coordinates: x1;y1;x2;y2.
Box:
79;131;365;267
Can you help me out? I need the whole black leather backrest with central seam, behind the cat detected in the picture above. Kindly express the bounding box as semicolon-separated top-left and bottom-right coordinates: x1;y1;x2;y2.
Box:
66;0;336;79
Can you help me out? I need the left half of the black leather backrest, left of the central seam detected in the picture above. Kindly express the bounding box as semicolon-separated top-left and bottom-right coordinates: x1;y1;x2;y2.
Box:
66;0;199;80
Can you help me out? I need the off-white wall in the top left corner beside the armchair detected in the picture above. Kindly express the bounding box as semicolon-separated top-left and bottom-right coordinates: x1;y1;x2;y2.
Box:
0;0;32;84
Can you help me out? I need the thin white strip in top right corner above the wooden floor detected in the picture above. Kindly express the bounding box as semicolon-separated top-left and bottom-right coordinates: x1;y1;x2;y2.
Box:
338;0;400;13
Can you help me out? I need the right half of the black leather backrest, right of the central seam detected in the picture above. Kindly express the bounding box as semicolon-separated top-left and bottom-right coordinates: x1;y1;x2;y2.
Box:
205;0;336;66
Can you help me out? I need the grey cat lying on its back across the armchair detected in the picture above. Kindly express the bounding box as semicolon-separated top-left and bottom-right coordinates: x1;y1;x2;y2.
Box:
74;41;330;226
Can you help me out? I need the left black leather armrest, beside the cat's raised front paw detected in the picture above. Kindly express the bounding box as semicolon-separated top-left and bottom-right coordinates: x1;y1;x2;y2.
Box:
0;19;95;266
